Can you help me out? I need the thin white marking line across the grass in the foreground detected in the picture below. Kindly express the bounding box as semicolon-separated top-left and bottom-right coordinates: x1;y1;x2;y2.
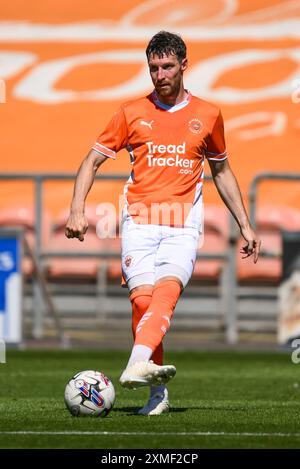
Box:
0;430;300;438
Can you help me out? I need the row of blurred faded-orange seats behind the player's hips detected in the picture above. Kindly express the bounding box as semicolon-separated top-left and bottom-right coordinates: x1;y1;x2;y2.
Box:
0;205;300;283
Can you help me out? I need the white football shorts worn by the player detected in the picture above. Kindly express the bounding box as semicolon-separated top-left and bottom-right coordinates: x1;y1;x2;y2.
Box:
122;217;199;290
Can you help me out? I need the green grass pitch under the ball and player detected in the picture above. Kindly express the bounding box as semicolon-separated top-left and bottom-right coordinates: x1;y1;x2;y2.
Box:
0;350;300;449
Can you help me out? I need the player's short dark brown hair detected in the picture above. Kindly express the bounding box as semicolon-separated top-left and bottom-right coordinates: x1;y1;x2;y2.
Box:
146;31;186;62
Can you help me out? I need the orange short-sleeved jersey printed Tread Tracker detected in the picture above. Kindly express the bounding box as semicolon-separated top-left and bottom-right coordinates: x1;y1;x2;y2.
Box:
93;91;227;230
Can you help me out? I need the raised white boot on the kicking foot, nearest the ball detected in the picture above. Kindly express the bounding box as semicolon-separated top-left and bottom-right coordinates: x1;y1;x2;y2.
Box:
120;361;176;389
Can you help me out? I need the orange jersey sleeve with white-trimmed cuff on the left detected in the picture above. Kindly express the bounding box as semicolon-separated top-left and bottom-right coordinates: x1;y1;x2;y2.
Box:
93;108;128;159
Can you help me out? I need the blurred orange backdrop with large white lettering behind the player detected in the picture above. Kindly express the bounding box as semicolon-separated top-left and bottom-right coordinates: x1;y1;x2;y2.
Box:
0;0;300;212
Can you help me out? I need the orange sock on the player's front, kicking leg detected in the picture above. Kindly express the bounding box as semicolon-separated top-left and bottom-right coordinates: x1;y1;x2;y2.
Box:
134;280;181;350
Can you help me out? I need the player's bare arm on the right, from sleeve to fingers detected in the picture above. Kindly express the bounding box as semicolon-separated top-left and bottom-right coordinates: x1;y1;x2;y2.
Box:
208;159;261;263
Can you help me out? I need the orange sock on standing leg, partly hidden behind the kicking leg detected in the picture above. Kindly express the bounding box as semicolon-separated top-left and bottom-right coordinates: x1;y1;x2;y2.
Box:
130;290;164;365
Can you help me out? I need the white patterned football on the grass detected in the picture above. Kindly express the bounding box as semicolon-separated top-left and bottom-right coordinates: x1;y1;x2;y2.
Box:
65;370;115;417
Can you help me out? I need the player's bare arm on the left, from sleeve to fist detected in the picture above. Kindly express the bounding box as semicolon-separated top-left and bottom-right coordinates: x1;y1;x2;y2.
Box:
65;150;107;241
